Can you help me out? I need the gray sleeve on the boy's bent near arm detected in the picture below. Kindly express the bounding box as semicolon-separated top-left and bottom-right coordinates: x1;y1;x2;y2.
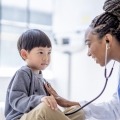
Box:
9;71;43;113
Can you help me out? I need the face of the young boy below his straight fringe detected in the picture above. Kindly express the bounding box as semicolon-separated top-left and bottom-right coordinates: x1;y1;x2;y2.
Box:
21;47;52;71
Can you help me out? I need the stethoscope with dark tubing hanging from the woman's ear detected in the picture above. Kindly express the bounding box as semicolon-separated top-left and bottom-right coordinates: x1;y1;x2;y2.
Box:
65;40;115;115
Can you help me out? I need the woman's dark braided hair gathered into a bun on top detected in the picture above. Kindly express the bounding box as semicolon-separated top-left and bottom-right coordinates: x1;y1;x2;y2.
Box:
90;0;120;42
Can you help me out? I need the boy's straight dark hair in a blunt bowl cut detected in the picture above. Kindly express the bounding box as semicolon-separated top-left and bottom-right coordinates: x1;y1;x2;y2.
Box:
17;29;52;52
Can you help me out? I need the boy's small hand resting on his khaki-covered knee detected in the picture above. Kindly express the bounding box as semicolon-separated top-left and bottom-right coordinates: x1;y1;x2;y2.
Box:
41;95;57;110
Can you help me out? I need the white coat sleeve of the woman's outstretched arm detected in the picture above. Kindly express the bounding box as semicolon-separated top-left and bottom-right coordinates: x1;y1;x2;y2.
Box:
80;93;120;120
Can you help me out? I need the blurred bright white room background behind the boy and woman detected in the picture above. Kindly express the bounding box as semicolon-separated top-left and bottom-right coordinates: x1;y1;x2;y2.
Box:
0;0;119;105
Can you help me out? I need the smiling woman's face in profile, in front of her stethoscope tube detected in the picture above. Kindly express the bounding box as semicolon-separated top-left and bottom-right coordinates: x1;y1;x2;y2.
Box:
85;28;108;66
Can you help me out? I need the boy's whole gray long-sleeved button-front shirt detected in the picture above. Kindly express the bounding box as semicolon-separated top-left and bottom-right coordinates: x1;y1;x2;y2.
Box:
5;66;48;120
